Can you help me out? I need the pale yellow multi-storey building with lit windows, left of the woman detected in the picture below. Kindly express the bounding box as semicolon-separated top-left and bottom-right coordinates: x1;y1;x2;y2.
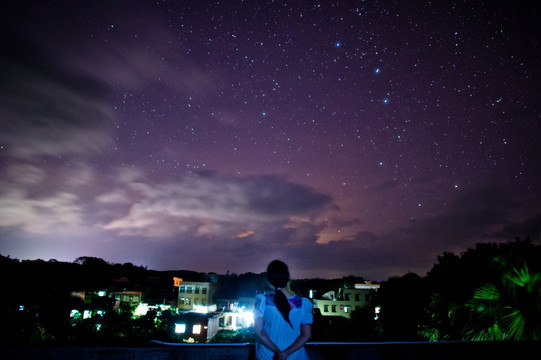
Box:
177;281;219;313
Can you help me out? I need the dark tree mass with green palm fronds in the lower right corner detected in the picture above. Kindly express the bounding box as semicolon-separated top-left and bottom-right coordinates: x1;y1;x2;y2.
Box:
375;239;541;341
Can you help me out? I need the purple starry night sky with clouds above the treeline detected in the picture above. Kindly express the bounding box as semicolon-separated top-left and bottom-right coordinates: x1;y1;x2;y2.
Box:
0;0;541;281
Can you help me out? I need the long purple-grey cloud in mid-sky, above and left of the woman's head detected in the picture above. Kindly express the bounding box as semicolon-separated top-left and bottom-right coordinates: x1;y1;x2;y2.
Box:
99;173;331;238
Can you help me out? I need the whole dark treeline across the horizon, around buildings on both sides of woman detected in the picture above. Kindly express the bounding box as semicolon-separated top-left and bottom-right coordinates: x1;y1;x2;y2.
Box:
0;239;541;345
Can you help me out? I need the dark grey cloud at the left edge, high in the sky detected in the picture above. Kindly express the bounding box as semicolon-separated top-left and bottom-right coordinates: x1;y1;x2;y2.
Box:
0;38;113;159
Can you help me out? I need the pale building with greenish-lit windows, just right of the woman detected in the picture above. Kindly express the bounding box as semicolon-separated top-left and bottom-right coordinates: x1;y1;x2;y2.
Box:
314;281;379;319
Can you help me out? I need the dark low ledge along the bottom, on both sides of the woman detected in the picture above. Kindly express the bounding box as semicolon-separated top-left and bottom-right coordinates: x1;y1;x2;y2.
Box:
0;341;541;360
